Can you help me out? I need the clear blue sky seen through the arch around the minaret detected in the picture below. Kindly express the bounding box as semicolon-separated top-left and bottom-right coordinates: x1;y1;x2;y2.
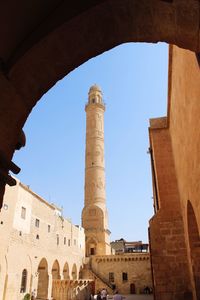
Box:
14;43;168;242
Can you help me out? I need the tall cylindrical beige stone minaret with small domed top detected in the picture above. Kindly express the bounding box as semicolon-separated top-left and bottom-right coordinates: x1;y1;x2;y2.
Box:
82;85;111;256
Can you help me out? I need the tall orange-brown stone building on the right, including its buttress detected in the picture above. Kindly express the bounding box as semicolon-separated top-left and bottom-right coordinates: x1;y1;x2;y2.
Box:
149;46;200;300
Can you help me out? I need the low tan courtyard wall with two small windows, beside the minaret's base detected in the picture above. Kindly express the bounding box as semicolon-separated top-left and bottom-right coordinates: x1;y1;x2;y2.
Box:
91;253;152;294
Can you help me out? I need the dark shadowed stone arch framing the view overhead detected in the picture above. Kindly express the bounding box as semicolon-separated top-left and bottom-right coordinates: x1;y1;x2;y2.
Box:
0;0;200;207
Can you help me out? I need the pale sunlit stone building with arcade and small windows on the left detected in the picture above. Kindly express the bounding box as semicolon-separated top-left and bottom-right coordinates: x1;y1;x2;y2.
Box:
0;180;91;300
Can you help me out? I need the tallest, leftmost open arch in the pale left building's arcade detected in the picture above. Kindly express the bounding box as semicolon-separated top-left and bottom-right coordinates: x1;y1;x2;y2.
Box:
37;258;49;299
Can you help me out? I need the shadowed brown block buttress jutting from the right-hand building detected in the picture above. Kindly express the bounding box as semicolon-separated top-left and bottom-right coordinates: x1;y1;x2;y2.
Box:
149;120;191;300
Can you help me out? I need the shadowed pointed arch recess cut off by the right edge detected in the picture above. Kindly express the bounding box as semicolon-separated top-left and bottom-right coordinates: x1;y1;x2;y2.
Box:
187;201;200;300
